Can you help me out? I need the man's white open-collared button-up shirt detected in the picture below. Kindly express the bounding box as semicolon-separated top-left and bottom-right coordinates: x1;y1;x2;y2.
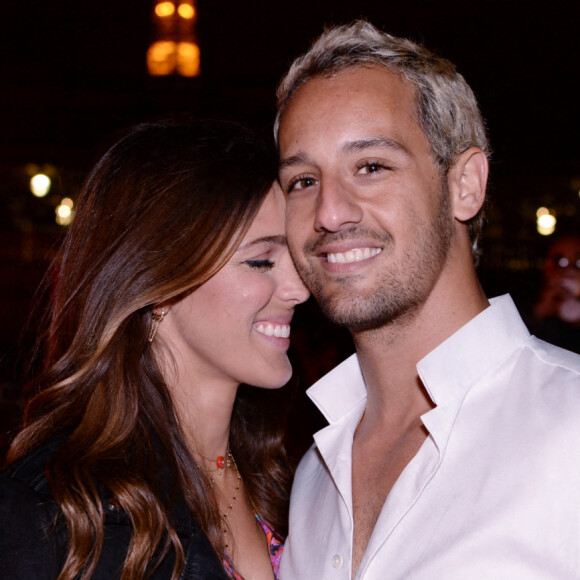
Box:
280;296;580;580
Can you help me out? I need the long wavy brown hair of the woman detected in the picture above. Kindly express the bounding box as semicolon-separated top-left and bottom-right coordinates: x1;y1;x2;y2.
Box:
8;120;289;580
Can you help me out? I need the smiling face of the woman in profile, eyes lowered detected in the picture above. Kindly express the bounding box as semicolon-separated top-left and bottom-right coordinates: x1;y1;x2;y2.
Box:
158;186;308;388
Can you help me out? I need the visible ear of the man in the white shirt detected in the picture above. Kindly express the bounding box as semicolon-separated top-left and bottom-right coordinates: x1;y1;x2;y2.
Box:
447;147;489;222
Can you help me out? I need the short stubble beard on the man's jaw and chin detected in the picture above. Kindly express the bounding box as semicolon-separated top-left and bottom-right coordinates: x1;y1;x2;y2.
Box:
297;184;454;333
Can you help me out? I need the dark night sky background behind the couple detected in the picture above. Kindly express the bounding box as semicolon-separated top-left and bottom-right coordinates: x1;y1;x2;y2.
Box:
0;0;580;450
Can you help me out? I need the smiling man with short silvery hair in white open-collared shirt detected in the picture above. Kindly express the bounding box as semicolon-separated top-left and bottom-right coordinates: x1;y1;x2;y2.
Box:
276;22;580;580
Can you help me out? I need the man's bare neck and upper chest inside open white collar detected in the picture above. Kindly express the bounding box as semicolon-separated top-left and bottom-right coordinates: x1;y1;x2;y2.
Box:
352;274;489;577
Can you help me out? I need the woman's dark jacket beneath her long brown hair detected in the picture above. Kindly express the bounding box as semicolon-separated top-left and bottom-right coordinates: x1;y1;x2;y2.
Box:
0;441;228;580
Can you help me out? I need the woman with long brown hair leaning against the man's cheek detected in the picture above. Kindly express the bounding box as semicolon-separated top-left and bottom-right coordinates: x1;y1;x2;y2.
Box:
0;115;308;580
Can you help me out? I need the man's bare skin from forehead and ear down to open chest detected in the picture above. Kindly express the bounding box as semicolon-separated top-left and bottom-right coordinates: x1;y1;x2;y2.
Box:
279;67;488;577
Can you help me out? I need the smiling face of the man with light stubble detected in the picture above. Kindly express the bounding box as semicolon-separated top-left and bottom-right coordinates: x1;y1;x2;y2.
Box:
279;67;454;331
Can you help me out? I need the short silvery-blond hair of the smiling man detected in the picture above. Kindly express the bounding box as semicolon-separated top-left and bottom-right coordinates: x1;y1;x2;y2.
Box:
274;20;490;262
